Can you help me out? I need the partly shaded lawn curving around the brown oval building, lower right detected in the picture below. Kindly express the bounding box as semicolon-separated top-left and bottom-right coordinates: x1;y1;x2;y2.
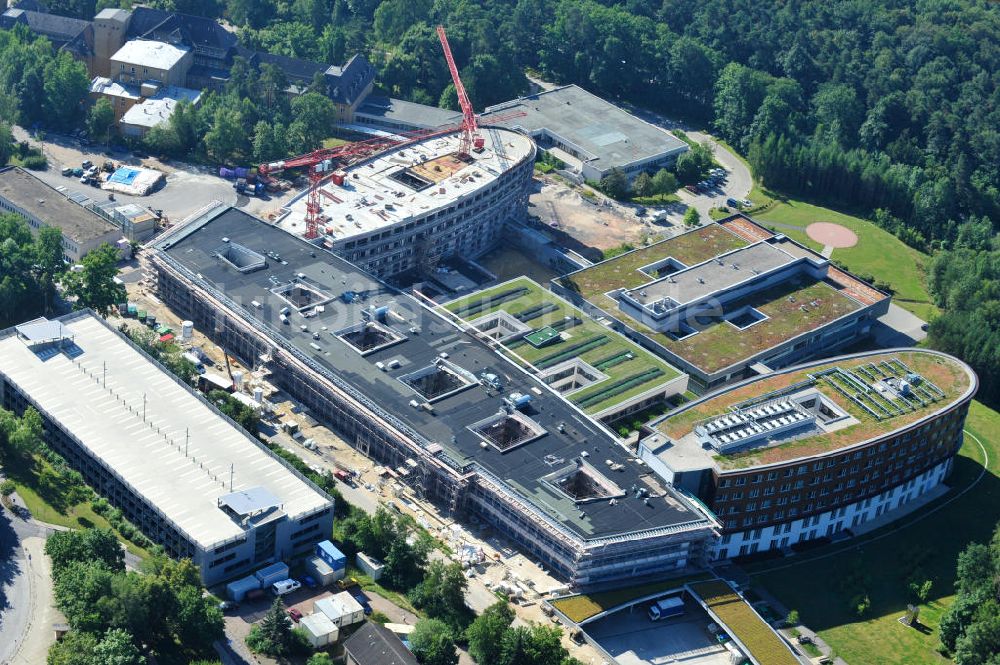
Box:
750;402;1000;665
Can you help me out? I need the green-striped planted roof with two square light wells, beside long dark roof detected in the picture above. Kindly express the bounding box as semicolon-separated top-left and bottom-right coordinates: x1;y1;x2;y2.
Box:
445;277;681;415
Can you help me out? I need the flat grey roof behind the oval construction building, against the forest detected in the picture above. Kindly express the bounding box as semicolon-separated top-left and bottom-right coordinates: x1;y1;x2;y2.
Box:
482;85;687;171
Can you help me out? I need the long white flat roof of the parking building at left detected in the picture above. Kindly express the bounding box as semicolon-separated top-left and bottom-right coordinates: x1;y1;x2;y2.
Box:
0;312;330;548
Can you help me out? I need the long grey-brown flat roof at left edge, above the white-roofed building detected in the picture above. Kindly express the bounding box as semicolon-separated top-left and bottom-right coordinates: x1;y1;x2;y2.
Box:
0;166;117;245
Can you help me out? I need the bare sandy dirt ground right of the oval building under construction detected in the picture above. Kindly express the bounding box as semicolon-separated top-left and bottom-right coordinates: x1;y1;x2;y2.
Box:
528;181;660;256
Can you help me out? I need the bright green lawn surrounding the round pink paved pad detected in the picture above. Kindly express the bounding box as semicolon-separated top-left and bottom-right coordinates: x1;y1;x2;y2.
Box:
750;186;938;320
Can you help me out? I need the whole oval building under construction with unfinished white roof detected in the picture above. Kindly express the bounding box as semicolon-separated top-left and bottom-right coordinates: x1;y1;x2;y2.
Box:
278;127;535;277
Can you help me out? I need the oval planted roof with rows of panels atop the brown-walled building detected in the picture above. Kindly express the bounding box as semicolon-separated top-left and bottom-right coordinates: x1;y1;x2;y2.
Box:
655;350;976;470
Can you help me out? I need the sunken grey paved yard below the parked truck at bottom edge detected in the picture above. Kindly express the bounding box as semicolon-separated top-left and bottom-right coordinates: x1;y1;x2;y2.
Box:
585;601;729;665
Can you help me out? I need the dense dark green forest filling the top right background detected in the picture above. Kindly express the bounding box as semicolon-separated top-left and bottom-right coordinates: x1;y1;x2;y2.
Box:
115;0;1000;242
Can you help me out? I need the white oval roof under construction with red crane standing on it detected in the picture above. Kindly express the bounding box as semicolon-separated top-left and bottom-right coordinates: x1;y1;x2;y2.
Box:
278;128;533;241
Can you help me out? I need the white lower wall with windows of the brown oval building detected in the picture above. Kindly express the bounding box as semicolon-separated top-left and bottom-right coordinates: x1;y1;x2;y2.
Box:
712;458;953;561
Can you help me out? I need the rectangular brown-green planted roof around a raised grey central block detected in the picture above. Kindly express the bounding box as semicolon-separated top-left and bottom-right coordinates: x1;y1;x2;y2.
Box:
556;217;887;373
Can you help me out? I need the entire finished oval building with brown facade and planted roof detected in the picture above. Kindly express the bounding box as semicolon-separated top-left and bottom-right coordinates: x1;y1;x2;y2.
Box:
640;349;978;559
